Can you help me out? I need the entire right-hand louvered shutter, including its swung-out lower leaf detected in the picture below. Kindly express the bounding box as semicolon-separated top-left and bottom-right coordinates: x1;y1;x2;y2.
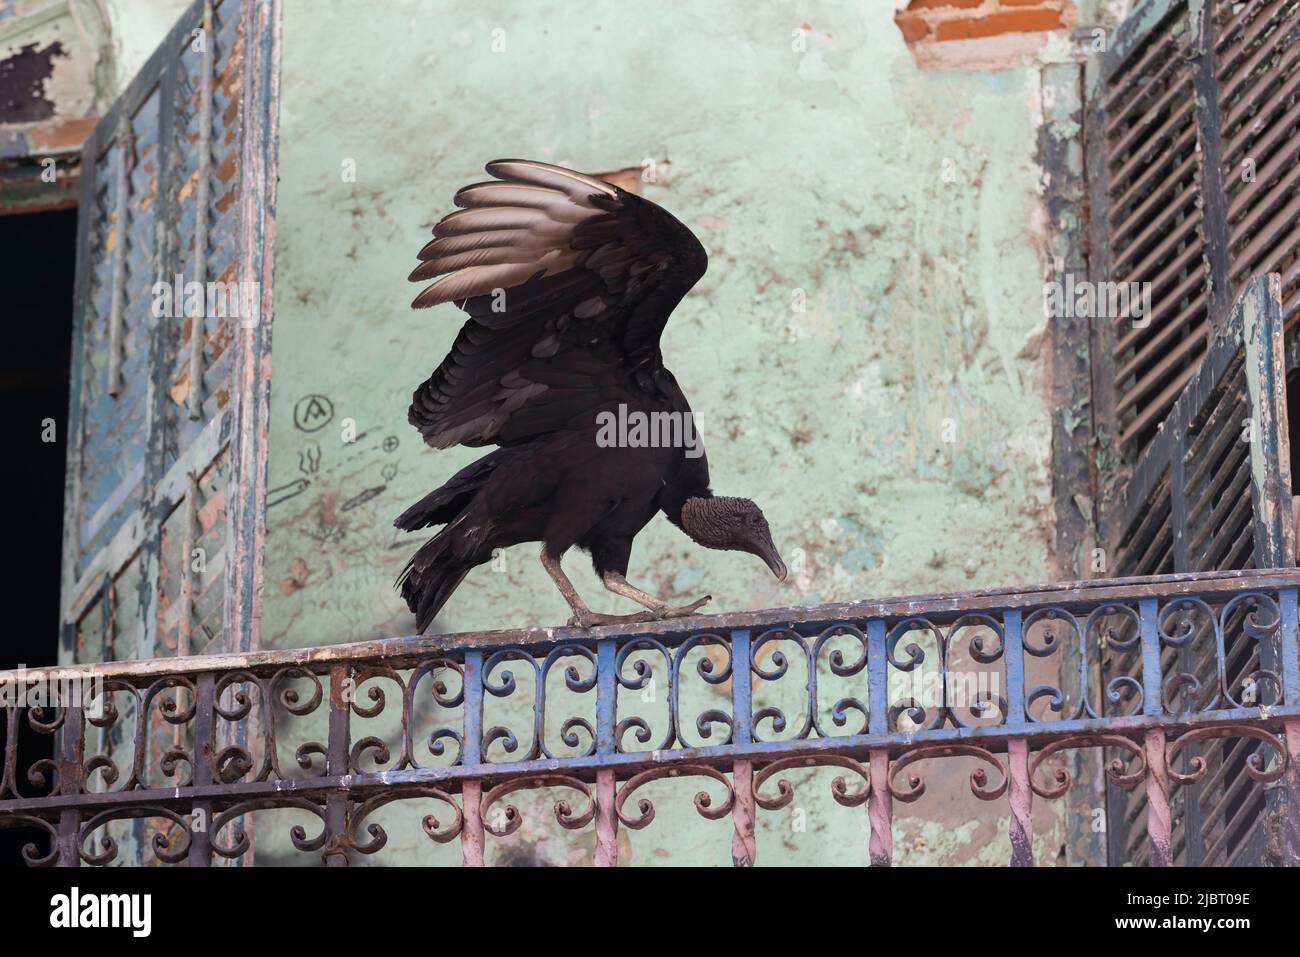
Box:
1084;0;1300;863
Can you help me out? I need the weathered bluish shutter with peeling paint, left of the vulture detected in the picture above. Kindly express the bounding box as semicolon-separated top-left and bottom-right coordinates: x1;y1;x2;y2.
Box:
61;0;274;661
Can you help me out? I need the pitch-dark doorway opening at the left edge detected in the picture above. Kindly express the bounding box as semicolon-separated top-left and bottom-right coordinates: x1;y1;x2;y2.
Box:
0;209;77;866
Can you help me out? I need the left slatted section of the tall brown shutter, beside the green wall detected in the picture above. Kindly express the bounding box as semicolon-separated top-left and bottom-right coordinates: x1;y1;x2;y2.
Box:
1087;3;1210;462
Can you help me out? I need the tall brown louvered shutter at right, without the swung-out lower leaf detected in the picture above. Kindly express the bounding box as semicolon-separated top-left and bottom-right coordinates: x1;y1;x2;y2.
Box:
1084;0;1300;475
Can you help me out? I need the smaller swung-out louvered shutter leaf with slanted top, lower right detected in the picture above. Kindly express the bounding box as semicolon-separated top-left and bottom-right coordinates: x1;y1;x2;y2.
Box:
1104;274;1295;865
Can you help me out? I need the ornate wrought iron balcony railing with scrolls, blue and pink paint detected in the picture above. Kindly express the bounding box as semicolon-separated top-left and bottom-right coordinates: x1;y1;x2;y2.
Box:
0;570;1300;866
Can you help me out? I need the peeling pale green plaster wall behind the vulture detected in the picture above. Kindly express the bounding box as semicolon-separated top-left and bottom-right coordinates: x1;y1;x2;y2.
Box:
259;0;1076;863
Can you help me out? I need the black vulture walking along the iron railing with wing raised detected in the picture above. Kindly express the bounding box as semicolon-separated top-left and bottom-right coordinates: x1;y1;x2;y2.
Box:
395;160;785;632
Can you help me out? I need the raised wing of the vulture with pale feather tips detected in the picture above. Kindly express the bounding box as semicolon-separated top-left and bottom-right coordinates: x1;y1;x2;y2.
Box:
410;160;709;449
